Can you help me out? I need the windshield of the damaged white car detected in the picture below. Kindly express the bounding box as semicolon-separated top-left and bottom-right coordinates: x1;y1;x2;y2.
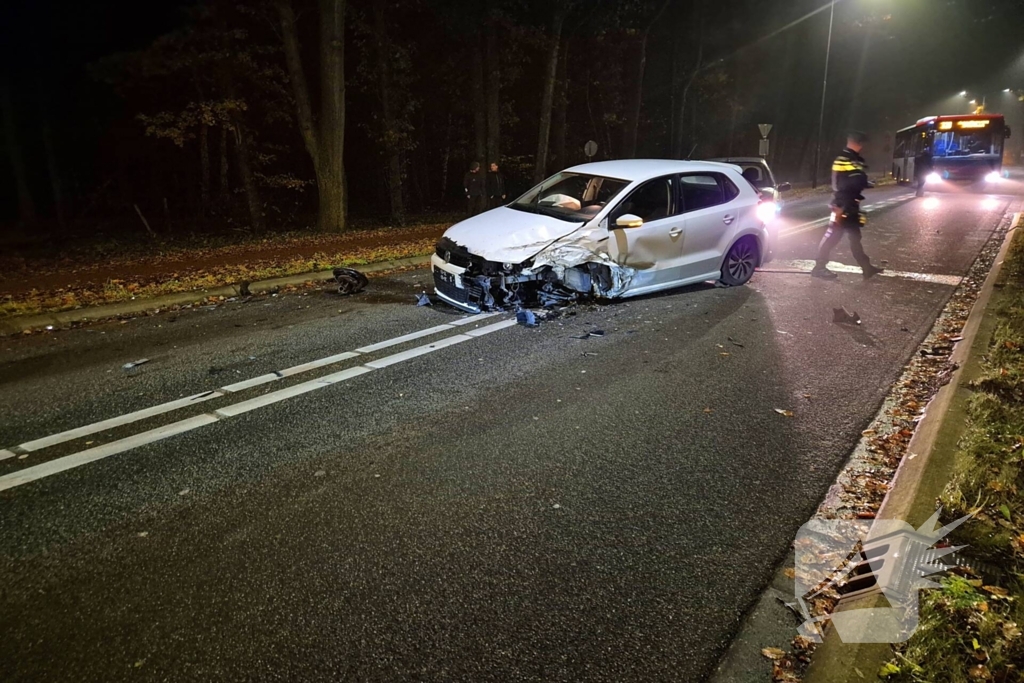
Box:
509;172;630;223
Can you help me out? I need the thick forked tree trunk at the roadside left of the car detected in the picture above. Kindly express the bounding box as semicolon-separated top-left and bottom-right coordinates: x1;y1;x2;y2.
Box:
275;0;347;232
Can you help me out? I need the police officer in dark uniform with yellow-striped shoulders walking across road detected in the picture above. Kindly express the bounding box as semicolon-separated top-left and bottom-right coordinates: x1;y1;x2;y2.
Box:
811;131;885;280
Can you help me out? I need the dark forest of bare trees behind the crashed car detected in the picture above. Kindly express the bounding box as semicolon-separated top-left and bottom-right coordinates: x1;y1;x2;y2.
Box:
0;0;1019;234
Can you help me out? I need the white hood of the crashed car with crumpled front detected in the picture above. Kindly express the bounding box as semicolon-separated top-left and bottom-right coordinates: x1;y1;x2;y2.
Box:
444;207;584;263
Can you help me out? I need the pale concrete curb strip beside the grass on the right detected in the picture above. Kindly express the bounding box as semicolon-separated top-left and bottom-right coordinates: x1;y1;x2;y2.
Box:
804;213;1022;683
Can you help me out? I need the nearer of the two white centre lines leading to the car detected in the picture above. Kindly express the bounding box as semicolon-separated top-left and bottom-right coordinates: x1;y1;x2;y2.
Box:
0;313;516;492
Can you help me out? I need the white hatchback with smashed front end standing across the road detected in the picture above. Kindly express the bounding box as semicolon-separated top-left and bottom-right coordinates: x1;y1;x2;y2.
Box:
431;160;774;312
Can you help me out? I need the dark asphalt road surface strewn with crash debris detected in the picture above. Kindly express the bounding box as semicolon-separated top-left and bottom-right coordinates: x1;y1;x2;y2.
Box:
0;174;1024;682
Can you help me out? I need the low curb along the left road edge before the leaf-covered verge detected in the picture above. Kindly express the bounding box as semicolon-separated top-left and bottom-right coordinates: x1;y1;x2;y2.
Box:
0;256;430;337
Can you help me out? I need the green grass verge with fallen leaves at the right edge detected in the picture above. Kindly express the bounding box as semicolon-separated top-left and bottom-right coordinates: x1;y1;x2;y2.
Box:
880;231;1024;683
